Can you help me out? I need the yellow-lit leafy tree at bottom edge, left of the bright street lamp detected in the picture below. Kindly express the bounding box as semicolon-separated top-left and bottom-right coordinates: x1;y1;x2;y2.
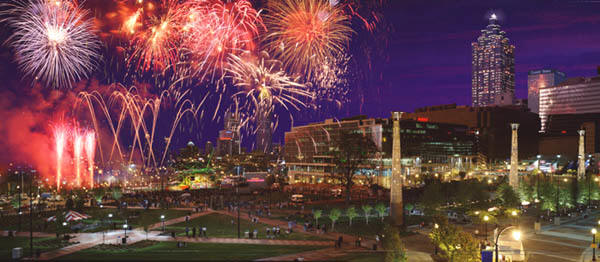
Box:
429;216;481;262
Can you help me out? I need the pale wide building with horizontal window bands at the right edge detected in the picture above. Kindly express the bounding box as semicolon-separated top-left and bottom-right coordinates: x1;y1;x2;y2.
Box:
540;76;600;132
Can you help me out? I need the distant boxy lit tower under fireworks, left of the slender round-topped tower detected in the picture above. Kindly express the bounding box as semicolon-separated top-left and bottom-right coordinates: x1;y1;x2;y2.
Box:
217;112;240;156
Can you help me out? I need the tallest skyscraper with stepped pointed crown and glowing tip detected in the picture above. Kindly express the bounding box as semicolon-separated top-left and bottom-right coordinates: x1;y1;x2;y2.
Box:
471;14;515;107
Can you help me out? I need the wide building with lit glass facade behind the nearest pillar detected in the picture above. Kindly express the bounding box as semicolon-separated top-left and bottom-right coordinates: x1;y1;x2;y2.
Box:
284;116;476;187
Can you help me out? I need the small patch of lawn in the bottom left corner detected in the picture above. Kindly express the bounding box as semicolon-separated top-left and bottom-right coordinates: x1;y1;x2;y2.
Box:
0;237;69;260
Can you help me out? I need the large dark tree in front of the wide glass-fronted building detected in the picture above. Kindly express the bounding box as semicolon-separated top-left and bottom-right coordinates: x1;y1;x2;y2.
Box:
330;130;377;204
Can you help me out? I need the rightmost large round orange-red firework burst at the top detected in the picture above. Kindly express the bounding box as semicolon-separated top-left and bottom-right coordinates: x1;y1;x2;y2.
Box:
265;0;352;77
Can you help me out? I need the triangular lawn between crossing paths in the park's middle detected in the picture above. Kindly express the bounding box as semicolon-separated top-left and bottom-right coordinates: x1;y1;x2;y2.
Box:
166;213;327;240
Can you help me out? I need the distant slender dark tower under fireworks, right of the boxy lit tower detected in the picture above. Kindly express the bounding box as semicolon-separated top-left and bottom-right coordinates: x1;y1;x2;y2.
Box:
254;99;273;153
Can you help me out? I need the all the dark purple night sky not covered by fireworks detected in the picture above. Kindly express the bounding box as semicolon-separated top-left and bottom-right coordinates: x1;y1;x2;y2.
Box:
0;0;600;162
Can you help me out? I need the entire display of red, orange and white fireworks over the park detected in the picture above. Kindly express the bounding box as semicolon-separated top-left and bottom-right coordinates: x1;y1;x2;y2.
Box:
0;0;386;189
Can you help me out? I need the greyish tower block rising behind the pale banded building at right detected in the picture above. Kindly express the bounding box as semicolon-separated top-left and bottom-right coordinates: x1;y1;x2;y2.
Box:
527;69;567;114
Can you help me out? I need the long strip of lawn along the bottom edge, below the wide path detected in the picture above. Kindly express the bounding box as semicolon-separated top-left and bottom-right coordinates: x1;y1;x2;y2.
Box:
59;241;323;261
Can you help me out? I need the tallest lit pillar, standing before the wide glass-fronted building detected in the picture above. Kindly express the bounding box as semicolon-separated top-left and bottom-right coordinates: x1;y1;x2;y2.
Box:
390;112;404;226
